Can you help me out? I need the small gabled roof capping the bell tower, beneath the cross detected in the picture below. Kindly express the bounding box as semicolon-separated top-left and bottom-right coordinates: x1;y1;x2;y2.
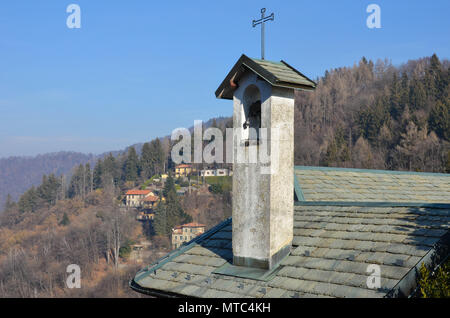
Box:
216;54;316;99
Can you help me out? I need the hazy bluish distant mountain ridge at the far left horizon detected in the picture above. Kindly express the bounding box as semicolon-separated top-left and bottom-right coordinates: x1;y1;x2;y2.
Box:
0;151;95;212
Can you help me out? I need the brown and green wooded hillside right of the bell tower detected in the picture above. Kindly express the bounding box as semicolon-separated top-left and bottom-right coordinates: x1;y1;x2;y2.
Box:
295;55;450;172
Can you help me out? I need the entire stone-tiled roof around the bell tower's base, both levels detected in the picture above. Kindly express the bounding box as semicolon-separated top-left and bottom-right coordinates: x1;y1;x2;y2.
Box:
130;167;450;297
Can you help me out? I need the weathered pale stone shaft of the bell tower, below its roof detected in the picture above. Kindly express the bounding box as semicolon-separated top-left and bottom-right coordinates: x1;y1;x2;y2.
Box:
233;72;294;268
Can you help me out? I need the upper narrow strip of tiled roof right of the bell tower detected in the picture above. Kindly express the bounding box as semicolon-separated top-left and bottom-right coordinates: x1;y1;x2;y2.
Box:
295;166;450;203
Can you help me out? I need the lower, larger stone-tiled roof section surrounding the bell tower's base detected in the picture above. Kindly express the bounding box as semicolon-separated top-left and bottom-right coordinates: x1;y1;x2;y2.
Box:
131;202;450;298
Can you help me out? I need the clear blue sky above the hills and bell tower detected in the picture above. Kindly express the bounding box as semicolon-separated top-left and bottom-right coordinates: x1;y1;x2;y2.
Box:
0;0;450;157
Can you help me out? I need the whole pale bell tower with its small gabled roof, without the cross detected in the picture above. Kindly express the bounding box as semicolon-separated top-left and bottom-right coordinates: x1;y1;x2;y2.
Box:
216;55;316;270
